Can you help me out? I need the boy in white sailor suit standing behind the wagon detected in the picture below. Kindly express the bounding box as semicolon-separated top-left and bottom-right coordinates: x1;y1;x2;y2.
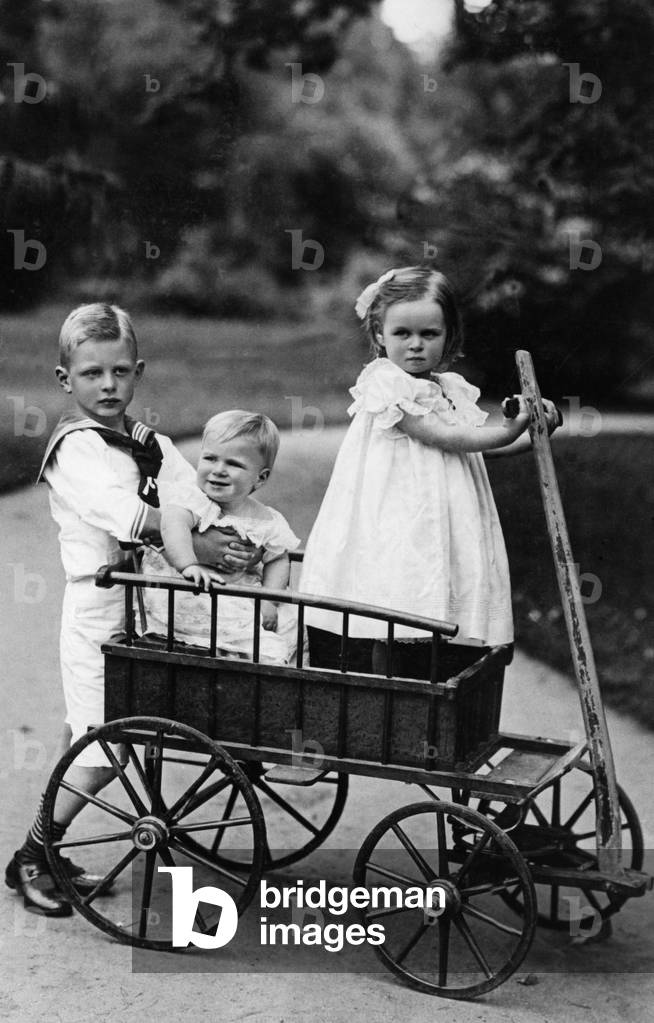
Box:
5;303;260;917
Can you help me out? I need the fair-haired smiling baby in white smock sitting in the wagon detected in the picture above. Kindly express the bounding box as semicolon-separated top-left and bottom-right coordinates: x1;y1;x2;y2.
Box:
142;409;300;664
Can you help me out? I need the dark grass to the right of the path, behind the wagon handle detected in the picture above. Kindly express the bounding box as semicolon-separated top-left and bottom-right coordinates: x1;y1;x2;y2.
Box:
488;434;654;728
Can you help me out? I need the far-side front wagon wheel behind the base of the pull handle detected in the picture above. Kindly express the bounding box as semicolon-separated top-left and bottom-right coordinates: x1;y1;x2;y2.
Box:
477;763;643;935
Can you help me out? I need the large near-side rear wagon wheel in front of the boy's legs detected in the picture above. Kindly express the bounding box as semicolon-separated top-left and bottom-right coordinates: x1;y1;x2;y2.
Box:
44;717;266;949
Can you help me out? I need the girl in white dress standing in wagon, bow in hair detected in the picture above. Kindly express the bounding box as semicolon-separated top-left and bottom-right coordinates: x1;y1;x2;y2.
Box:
300;267;556;673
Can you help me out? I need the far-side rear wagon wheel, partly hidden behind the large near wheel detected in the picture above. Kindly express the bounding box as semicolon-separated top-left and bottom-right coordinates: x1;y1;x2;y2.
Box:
171;761;348;871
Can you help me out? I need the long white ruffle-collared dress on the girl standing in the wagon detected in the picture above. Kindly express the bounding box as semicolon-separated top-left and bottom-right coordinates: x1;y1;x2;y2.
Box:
300;358;513;646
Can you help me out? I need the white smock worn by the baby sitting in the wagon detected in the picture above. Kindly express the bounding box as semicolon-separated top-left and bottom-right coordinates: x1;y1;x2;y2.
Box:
142;484;300;664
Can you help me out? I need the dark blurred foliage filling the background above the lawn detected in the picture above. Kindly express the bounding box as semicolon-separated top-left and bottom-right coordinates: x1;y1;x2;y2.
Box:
0;0;654;399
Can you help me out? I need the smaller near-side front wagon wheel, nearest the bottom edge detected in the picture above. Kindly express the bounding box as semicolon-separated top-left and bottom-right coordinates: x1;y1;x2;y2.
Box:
354;802;536;998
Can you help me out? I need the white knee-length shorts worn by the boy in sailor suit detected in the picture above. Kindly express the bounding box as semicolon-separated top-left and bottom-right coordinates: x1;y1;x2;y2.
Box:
59;578;125;767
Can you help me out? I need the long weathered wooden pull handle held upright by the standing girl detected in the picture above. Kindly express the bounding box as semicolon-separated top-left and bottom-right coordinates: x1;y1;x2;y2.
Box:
510;351;623;875
